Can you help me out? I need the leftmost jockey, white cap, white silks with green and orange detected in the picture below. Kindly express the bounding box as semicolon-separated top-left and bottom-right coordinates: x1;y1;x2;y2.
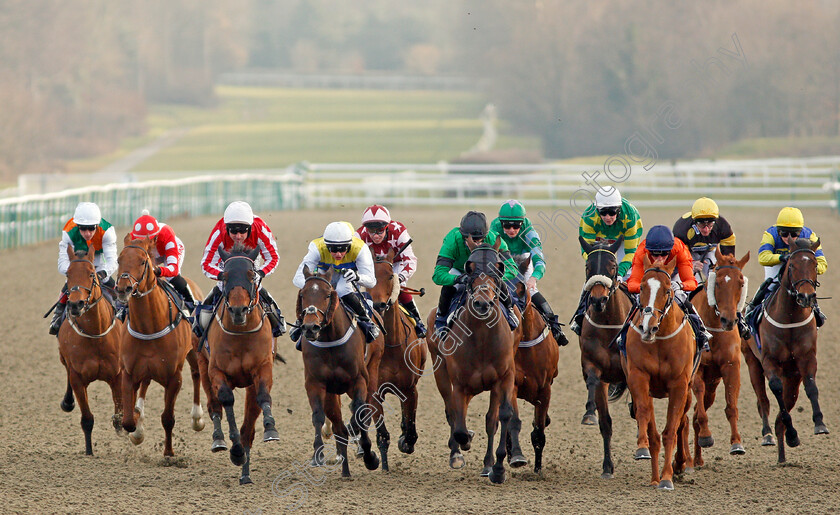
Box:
50;202;117;335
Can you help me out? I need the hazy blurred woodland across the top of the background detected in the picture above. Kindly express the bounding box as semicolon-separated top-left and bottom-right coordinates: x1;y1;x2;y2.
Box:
0;0;840;178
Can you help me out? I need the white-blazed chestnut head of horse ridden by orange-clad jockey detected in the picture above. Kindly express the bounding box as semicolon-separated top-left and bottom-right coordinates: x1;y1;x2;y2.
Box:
639;254;677;342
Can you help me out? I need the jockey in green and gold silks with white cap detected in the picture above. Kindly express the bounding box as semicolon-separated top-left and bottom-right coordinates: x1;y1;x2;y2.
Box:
569;187;642;336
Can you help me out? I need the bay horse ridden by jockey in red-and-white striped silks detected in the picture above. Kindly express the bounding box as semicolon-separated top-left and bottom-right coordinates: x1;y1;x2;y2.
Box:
198;243;280;485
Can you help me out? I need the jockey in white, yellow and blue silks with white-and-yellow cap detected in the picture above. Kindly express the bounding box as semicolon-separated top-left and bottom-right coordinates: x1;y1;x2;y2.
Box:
289;222;379;350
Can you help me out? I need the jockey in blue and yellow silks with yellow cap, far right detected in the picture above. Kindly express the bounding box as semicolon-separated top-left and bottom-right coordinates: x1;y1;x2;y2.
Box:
747;207;828;327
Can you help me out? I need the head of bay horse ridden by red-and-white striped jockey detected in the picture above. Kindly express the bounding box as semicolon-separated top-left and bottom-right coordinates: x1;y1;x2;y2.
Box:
219;243;260;326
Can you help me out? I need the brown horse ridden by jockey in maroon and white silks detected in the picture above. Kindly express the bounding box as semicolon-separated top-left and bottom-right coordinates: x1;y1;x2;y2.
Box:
368;251;428;471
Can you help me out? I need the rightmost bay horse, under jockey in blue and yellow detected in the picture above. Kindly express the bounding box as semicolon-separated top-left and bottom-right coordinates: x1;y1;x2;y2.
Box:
747;238;828;463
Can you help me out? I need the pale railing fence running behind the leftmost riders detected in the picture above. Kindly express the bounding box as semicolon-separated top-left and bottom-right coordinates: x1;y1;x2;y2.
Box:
0;173;303;249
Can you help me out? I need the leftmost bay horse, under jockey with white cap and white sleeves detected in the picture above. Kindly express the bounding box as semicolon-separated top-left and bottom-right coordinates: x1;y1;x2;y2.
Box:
58;245;123;455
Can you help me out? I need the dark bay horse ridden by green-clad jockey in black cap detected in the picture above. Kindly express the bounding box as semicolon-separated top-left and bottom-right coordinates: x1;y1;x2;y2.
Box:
426;239;528;484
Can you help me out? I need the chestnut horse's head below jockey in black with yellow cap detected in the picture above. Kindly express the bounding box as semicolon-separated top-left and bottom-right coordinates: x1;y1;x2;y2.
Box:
706;248;750;331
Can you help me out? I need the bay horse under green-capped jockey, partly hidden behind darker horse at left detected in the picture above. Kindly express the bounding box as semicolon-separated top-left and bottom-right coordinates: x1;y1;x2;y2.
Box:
508;280;560;473
